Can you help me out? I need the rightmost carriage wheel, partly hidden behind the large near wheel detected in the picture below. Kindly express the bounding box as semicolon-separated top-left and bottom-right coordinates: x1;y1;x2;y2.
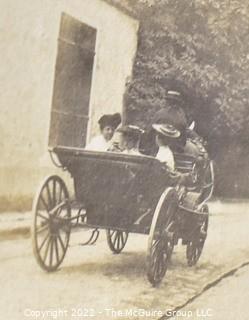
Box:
186;204;208;267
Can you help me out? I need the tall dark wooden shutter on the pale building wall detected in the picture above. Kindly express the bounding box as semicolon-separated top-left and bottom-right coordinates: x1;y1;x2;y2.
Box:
49;14;96;147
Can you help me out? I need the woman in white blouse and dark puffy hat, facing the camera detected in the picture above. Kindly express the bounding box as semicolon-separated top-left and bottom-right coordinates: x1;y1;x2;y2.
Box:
85;113;121;151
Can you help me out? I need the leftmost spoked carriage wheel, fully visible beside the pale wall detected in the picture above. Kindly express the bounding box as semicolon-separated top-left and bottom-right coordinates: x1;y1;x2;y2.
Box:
31;175;71;271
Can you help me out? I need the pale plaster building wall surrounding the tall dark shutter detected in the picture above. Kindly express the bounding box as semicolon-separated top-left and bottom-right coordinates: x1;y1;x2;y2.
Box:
0;0;138;210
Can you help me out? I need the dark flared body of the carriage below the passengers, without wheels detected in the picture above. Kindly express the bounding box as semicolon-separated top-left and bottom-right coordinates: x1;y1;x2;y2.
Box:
54;147;170;234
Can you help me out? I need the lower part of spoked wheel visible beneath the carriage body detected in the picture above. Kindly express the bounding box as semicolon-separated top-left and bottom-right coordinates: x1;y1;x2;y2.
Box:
106;229;128;254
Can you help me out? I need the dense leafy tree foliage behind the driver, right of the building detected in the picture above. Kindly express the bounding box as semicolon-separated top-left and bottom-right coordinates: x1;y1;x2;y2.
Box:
105;0;249;196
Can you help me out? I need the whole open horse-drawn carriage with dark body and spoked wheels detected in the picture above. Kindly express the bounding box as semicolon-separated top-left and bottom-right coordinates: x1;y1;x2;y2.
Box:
32;133;213;285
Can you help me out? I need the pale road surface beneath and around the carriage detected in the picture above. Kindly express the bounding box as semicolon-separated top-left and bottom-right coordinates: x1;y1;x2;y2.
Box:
0;202;249;320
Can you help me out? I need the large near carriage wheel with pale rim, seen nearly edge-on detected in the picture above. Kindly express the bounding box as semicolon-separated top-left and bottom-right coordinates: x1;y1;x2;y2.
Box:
147;188;178;286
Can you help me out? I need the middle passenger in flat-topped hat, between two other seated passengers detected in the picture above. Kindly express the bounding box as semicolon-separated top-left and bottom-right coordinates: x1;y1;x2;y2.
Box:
117;125;143;155
